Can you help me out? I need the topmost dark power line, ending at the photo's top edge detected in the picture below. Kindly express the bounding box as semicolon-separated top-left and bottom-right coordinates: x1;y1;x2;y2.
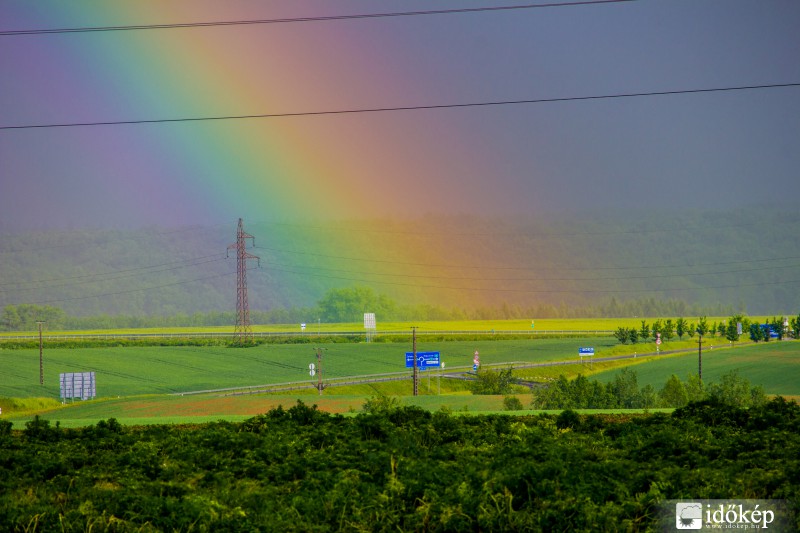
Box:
0;0;637;37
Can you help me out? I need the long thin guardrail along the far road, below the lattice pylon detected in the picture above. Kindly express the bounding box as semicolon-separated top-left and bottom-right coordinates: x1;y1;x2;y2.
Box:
0;329;614;341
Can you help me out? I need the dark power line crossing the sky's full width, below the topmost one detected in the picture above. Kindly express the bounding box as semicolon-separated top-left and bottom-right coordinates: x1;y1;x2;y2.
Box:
0;83;800;130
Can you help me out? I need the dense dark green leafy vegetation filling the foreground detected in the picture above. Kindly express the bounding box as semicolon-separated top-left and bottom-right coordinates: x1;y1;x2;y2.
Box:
0;398;800;531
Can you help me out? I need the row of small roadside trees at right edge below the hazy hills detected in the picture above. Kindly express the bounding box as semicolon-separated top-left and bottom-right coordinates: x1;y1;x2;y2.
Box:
614;315;800;344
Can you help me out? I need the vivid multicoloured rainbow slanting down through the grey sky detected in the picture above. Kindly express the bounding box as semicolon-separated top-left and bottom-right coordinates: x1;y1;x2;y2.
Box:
3;2;544;308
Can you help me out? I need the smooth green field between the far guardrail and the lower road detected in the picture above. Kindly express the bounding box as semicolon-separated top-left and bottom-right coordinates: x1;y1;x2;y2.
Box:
0;337;616;398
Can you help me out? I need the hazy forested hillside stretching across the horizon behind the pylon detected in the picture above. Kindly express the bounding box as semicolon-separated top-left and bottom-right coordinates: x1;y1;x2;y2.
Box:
0;209;800;327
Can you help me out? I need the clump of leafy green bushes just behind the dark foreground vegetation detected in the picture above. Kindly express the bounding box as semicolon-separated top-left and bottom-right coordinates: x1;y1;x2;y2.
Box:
531;368;767;409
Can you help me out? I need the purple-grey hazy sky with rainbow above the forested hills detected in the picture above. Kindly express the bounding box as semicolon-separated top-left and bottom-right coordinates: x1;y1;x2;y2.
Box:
0;0;800;232
